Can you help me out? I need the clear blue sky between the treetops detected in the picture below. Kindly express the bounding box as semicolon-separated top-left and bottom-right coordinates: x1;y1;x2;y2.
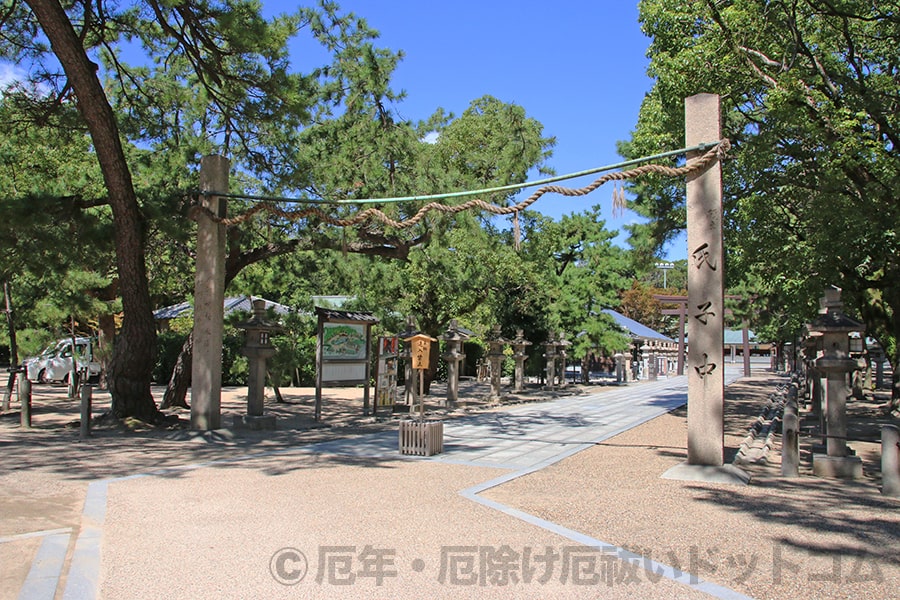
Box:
278;0;685;259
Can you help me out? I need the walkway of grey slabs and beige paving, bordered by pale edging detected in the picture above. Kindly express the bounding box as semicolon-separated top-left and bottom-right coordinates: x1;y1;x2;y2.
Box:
12;369;743;599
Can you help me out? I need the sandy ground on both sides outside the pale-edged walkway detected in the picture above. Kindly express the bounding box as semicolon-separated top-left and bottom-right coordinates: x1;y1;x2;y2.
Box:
0;373;900;598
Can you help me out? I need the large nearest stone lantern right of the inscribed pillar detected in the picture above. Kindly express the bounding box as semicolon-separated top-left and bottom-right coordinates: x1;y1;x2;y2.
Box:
809;288;864;479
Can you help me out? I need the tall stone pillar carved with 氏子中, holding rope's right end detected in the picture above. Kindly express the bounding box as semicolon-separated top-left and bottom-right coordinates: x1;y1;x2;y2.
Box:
685;94;725;466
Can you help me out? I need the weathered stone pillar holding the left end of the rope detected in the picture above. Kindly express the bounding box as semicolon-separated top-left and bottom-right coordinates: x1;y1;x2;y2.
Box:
191;155;229;430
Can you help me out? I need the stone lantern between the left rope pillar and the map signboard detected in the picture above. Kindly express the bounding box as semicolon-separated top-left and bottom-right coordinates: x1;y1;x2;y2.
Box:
234;299;282;429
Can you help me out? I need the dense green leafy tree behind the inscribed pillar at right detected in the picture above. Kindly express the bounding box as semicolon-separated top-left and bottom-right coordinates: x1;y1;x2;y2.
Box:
623;0;900;408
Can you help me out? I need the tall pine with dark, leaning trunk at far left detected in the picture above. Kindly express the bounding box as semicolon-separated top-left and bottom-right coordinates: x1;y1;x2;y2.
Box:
0;0;428;420
